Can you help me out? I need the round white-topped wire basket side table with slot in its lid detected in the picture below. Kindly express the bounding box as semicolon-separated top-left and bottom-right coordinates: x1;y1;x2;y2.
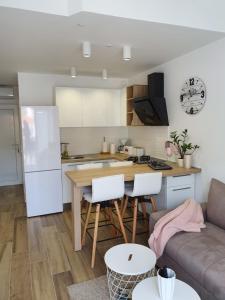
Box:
105;244;156;300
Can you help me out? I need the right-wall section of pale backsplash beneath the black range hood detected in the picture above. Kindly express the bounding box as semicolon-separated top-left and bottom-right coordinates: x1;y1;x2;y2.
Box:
128;126;169;159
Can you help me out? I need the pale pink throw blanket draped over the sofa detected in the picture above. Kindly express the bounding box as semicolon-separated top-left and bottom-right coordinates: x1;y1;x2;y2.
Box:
148;199;206;258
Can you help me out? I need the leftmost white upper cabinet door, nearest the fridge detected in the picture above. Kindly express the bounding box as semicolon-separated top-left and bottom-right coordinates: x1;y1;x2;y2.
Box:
56;87;83;127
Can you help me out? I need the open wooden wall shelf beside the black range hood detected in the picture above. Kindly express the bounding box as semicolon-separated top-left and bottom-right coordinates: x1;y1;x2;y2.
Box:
127;84;148;126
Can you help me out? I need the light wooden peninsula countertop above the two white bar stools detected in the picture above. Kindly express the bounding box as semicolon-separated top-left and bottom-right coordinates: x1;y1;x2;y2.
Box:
66;161;201;187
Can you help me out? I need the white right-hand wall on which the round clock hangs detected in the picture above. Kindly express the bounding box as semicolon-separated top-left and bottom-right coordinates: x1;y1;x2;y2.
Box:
130;39;225;200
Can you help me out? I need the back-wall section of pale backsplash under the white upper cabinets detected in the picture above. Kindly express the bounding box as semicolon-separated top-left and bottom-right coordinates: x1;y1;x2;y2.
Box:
60;127;128;155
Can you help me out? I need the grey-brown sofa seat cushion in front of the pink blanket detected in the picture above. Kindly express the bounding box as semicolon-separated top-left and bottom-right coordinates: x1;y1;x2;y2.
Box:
164;223;225;299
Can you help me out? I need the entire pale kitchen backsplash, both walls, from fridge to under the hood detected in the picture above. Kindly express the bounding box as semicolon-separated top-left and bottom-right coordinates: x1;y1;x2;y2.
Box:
60;126;168;158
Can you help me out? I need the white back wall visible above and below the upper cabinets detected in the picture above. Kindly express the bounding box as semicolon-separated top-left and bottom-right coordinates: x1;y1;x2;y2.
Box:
18;73;128;154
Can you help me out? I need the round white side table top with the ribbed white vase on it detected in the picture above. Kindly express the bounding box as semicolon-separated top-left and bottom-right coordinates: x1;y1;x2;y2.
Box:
132;276;201;300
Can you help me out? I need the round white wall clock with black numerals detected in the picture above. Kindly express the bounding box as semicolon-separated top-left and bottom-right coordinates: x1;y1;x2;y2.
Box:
180;77;206;115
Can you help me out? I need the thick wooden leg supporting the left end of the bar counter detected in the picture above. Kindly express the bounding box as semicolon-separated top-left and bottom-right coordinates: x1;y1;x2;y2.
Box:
72;185;82;251
